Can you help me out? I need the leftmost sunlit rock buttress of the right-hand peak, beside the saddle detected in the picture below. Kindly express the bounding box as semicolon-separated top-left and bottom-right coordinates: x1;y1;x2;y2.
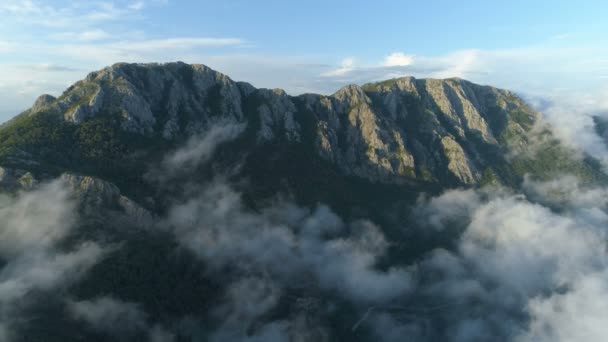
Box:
303;85;415;181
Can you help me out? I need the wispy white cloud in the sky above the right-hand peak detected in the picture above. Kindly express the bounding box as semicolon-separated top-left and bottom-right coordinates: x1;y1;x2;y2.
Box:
321;43;608;95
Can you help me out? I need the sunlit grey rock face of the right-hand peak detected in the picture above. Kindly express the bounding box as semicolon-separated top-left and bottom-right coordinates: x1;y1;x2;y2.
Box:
298;77;538;184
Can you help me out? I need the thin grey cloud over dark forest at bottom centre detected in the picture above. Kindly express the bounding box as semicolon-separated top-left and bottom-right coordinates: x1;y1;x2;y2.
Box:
161;182;412;341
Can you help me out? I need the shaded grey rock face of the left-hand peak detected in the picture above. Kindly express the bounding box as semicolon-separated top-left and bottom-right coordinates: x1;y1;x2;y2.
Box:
32;62;243;139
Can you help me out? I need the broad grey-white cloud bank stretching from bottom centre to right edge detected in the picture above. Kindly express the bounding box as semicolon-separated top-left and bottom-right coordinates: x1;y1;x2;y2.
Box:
150;121;608;341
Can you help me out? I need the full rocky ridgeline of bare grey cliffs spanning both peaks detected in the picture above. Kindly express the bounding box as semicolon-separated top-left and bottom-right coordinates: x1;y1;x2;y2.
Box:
29;62;538;184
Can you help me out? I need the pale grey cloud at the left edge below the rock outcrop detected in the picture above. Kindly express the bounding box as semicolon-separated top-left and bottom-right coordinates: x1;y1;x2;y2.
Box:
0;181;104;341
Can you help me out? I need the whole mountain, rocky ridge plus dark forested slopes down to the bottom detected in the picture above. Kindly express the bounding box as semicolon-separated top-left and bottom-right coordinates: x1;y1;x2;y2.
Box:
0;62;606;341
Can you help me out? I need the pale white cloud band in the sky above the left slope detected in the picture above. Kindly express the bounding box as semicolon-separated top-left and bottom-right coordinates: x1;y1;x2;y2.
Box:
0;34;245;122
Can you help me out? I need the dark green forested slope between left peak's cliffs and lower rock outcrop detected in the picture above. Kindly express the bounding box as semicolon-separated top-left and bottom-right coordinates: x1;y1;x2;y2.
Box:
0;112;168;198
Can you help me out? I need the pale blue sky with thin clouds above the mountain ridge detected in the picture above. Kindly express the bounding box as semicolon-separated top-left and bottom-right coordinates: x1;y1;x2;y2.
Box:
0;0;608;121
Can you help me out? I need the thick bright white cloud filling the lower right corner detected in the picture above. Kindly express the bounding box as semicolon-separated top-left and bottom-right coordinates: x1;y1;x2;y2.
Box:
363;184;608;342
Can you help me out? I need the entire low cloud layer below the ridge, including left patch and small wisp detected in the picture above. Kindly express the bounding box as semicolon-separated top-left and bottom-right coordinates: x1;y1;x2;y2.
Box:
0;119;608;342
